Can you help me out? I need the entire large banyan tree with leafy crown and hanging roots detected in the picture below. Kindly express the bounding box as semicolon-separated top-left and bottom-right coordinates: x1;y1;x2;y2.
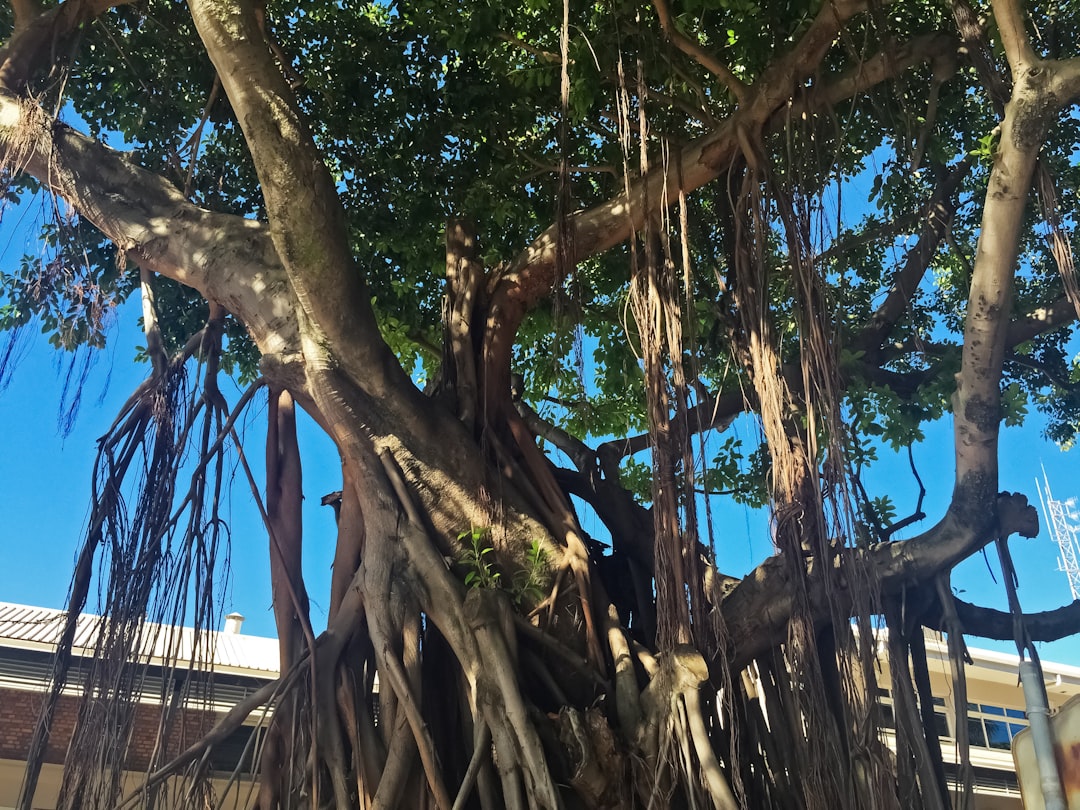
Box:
0;0;1080;810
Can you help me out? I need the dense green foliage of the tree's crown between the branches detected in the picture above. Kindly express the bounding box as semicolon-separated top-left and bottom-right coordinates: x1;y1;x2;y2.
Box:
0;0;1080;520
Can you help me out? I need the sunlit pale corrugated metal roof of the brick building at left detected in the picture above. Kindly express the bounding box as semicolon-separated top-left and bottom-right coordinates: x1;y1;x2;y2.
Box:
0;602;280;678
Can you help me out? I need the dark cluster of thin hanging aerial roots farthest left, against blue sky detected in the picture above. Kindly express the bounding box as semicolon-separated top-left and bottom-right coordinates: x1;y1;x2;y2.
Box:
29;304;261;807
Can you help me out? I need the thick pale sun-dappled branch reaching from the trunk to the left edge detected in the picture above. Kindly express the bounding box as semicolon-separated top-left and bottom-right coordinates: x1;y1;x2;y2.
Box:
0;91;298;363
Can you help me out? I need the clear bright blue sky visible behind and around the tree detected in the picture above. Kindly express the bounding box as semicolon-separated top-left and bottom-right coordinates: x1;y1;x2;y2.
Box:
0;198;1080;665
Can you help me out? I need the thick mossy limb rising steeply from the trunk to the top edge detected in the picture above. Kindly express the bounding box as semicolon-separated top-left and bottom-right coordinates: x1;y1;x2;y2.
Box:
190;0;489;548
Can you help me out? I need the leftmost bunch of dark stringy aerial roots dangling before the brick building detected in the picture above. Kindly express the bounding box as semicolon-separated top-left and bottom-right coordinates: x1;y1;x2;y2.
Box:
19;287;240;808
